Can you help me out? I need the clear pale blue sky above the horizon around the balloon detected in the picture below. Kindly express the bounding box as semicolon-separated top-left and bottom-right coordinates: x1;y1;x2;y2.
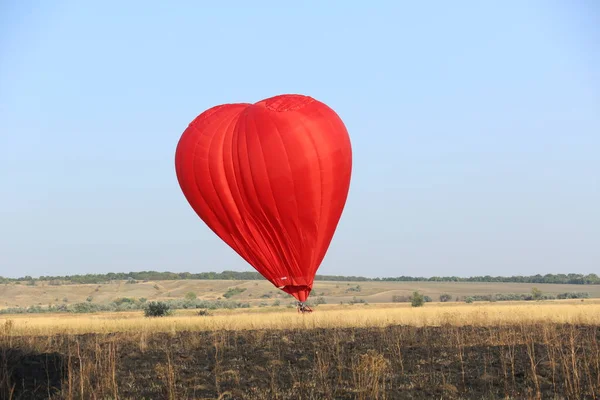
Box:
0;0;600;277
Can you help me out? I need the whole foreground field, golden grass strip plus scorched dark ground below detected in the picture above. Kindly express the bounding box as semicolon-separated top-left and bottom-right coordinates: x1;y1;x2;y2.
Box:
0;299;600;400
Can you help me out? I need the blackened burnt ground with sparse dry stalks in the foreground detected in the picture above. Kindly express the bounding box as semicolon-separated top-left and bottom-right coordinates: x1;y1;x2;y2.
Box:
0;324;600;400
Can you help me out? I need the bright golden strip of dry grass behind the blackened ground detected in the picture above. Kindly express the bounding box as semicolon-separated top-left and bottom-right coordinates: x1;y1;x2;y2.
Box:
0;299;600;335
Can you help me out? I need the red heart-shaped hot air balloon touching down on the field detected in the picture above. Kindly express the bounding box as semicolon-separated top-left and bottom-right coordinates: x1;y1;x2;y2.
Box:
175;94;352;307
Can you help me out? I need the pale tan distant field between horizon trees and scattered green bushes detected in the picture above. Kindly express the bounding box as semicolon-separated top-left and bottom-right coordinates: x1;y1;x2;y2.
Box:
0;280;600;308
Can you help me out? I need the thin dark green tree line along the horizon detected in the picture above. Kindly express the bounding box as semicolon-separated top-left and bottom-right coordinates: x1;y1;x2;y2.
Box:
0;271;600;285
